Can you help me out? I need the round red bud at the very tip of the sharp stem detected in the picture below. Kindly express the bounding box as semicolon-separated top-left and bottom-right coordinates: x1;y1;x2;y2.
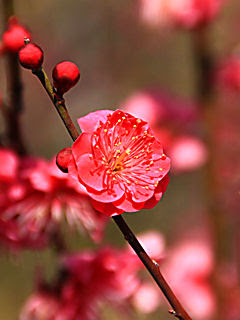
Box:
18;43;43;69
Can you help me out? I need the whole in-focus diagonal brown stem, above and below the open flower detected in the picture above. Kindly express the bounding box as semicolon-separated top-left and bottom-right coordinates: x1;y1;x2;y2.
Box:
33;65;191;320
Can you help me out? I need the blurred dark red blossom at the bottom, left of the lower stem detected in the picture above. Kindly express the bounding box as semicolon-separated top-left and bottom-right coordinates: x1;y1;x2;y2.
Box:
20;247;141;320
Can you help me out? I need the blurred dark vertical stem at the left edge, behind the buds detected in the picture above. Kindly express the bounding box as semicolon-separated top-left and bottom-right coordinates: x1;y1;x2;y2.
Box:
3;0;26;154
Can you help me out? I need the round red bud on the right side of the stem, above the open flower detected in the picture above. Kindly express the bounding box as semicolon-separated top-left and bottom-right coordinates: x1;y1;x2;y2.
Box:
52;61;80;95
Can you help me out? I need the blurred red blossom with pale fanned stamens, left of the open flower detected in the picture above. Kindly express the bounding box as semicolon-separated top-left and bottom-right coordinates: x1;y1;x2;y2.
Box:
0;149;107;247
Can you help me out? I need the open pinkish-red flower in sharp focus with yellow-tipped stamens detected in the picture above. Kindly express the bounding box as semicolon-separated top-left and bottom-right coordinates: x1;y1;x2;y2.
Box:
68;110;170;216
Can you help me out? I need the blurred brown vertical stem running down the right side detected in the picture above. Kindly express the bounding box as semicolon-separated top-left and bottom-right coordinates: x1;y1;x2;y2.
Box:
192;27;230;319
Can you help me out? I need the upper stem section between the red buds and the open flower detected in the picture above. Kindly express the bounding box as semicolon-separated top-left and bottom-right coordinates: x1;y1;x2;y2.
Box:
33;68;79;140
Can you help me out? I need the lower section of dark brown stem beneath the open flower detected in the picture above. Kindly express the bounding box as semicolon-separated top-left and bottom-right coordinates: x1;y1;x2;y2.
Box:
113;215;191;320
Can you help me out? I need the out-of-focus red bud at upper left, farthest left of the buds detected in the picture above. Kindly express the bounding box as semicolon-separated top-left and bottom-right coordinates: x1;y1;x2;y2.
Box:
2;18;31;53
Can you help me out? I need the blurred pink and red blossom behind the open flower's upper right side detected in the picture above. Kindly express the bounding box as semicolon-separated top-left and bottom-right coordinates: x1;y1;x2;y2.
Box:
125;89;207;173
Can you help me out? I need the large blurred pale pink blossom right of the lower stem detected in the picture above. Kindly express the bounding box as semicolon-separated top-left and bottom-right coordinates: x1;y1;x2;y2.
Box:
163;239;215;319
